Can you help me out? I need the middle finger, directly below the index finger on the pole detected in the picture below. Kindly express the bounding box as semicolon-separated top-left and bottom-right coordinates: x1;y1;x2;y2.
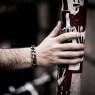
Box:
58;43;85;50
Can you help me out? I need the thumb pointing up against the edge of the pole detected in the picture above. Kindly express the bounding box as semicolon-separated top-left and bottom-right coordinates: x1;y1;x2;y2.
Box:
49;21;61;37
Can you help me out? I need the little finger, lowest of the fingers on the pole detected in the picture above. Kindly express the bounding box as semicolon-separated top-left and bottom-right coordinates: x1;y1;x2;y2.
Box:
59;58;82;65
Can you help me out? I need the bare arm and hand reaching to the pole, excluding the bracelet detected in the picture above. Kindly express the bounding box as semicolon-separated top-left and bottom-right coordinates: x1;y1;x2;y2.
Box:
0;22;84;69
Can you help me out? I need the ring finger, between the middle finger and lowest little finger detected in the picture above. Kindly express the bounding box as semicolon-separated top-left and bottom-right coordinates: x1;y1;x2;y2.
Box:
58;51;84;58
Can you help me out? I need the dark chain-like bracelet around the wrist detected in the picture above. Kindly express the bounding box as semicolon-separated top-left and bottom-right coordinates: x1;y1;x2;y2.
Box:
31;45;37;68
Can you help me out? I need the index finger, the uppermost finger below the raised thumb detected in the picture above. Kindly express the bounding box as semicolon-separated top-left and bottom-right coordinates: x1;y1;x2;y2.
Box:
55;32;81;42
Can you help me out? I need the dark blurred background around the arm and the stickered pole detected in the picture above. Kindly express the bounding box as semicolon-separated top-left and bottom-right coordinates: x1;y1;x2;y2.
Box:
0;0;95;95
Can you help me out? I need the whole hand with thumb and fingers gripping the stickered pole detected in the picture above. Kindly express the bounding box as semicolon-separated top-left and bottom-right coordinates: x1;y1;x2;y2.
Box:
36;21;84;67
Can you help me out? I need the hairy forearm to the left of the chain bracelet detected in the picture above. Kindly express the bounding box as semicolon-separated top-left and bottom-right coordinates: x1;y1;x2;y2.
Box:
0;48;32;69
